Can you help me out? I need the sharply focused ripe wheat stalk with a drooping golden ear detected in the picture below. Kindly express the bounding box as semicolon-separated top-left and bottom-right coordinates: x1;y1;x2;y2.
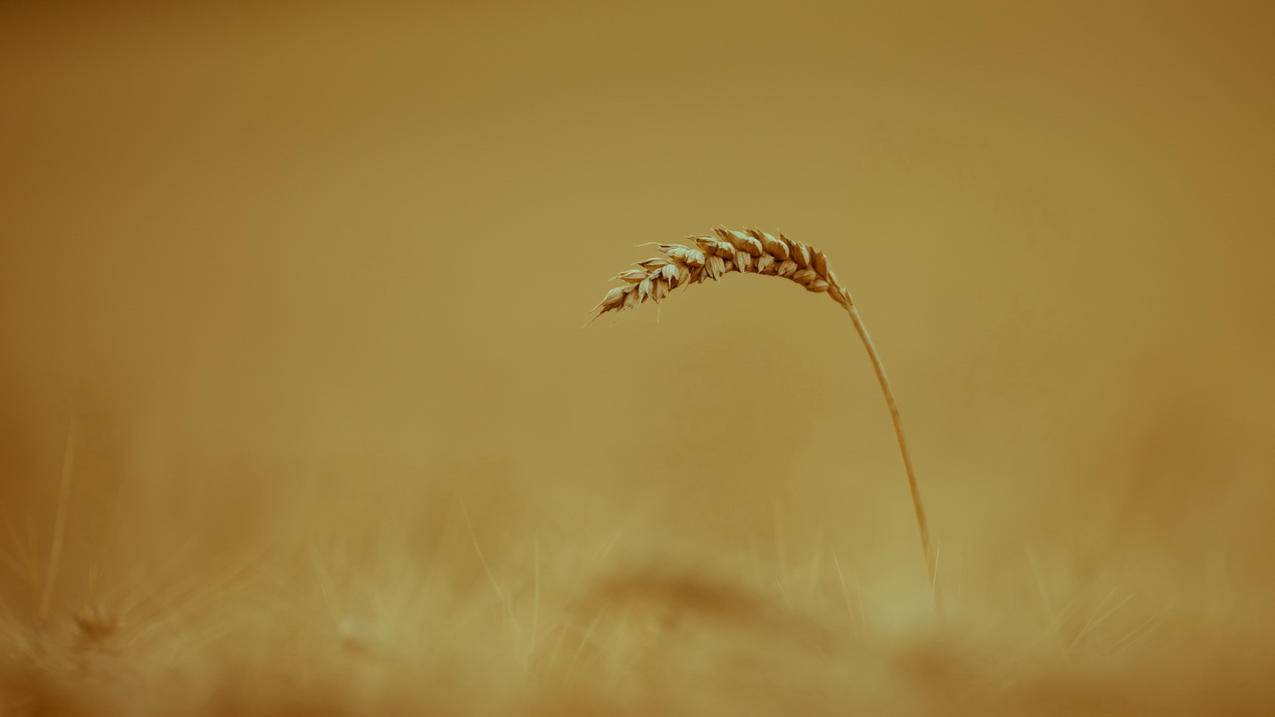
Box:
593;227;940;609
